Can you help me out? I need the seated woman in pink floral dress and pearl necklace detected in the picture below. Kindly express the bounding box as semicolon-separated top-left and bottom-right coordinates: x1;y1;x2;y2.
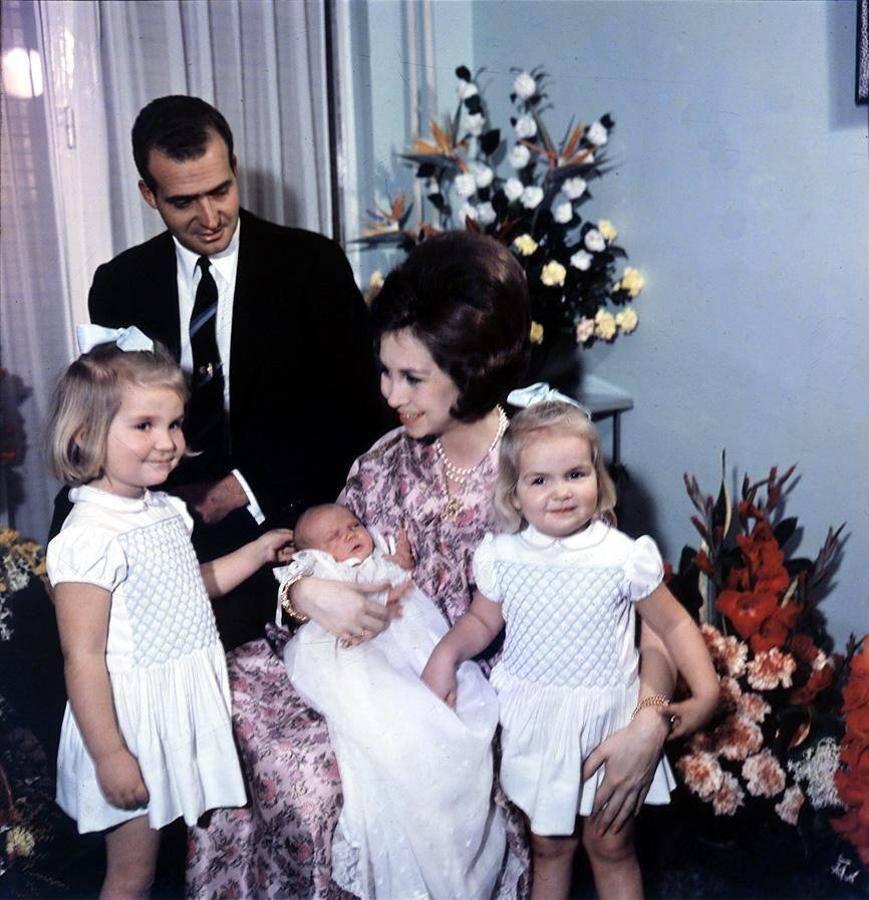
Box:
187;232;672;898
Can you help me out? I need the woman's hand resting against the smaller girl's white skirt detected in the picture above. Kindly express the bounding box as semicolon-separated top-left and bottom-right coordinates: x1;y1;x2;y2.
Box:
582;707;669;835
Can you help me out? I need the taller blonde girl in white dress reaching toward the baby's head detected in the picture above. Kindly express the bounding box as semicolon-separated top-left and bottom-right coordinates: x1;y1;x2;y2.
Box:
46;326;292;898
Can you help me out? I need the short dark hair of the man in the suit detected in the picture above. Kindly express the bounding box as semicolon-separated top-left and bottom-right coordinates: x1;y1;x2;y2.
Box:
133;94;233;191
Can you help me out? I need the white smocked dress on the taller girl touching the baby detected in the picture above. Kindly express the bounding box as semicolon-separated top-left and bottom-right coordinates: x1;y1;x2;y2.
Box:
46;486;245;833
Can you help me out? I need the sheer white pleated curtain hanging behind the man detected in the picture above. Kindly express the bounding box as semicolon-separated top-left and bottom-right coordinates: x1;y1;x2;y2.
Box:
0;0;332;539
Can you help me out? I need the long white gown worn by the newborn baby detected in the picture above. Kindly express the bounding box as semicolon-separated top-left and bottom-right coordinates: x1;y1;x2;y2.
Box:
284;550;506;900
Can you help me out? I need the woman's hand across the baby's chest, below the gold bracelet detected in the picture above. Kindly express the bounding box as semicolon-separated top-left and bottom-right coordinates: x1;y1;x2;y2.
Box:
290;576;400;645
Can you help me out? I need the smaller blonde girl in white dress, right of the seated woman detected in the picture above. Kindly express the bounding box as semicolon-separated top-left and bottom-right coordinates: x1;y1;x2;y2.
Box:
422;385;718;900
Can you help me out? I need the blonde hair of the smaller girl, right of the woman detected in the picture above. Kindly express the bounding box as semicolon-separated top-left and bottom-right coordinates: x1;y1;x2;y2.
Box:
492;400;616;534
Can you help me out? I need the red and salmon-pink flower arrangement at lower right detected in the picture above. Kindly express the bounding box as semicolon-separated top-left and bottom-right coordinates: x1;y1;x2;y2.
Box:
670;456;869;881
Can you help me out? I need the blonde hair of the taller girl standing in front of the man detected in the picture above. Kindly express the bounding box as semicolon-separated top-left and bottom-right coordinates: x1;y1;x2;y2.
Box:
46;341;187;485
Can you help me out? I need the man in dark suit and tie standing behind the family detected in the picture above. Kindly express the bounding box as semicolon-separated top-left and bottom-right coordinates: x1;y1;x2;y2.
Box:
59;96;384;649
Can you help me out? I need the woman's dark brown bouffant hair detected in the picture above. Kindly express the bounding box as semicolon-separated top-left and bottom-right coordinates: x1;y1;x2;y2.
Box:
371;231;531;422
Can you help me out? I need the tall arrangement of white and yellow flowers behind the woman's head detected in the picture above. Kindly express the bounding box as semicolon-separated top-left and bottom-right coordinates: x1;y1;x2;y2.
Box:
360;66;645;358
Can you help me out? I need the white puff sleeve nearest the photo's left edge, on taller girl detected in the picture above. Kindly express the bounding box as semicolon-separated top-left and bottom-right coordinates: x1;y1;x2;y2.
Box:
45;526;127;592
